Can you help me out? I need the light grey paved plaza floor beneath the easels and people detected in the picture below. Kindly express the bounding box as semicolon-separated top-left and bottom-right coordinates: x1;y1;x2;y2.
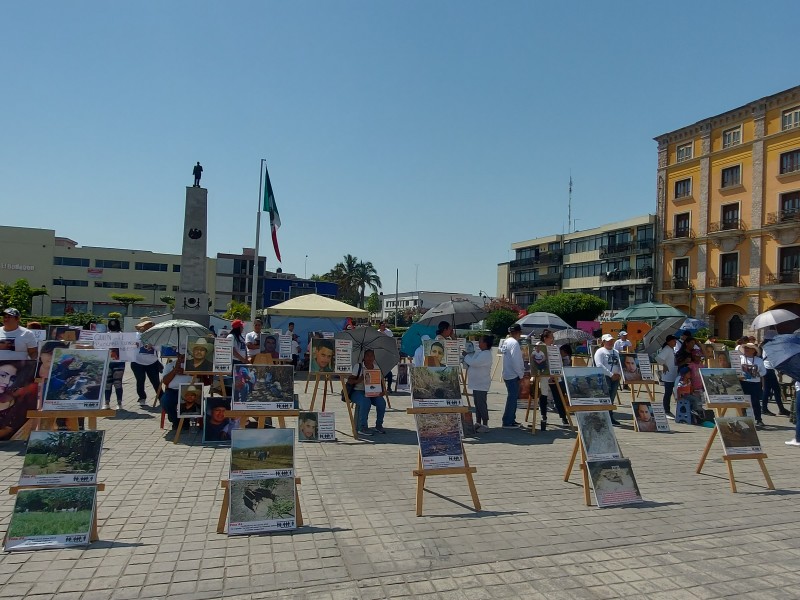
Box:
0;369;800;600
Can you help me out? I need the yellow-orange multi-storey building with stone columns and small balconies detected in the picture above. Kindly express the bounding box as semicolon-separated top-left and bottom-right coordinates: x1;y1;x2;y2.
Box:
655;86;800;339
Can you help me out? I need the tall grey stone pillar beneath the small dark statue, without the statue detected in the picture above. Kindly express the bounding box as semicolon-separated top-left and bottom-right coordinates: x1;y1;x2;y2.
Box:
173;186;209;327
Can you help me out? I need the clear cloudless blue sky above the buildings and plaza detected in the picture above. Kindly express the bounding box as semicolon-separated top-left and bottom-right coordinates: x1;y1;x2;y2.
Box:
0;0;800;295
